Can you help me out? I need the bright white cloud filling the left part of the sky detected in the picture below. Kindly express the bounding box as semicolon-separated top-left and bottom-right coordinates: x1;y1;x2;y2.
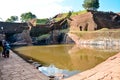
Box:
0;0;72;20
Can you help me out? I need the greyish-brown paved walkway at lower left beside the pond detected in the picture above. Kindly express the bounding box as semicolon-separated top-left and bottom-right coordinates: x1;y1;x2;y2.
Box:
0;51;50;80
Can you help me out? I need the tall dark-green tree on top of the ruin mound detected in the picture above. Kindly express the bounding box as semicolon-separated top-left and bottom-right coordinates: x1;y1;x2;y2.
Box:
82;0;99;11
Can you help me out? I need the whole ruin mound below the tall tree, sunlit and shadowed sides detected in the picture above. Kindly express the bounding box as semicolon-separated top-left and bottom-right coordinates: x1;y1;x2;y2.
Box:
69;11;120;31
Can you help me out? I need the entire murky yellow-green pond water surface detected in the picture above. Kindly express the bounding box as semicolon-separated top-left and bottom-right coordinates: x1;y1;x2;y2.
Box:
15;45;118;71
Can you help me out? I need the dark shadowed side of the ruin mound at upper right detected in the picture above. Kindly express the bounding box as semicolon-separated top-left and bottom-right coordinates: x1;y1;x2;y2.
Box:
92;12;120;30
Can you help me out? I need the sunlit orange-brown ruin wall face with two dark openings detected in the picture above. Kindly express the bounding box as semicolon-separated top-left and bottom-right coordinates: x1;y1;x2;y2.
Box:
69;12;96;31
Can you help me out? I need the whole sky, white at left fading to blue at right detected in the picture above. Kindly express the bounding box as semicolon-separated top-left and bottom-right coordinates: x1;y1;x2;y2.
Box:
0;0;120;21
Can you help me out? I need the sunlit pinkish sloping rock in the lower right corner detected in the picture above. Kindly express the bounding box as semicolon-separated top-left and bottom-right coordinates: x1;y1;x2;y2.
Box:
64;53;120;80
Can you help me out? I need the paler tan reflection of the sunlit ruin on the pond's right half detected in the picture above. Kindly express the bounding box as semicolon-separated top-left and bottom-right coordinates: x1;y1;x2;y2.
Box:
68;45;119;71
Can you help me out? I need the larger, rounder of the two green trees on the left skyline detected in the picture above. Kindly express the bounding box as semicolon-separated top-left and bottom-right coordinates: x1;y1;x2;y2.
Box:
21;12;36;22
